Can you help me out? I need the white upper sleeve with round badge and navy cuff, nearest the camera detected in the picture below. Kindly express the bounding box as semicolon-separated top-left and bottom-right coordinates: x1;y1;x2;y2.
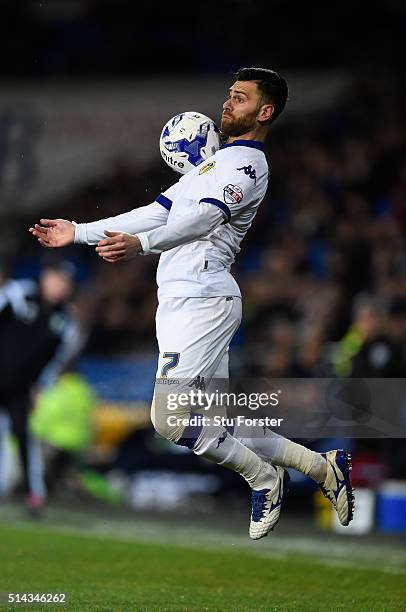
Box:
190;160;263;223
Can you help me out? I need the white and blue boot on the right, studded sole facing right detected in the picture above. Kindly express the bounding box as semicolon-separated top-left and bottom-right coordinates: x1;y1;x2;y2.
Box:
319;450;354;527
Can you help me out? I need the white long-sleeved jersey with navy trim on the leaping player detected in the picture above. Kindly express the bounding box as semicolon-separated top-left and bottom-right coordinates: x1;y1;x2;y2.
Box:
75;140;268;298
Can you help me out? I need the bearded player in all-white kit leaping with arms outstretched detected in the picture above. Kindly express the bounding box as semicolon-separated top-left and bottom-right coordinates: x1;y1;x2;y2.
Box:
30;68;353;539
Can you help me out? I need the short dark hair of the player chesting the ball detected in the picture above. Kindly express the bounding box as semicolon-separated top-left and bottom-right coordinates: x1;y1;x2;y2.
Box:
234;68;288;124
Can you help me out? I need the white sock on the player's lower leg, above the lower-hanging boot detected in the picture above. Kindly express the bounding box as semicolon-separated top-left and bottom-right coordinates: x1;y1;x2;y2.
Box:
193;427;276;490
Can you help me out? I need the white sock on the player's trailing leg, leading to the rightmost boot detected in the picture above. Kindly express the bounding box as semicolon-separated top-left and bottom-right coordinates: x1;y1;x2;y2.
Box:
234;426;327;483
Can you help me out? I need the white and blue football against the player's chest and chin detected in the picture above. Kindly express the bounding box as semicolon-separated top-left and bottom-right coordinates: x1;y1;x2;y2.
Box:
159;111;221;174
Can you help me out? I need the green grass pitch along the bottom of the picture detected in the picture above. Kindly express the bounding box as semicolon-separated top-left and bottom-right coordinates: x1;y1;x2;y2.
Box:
0;517;406;612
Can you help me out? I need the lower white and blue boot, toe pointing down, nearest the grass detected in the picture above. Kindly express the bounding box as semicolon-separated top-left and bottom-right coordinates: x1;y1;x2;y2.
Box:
250;467;290;540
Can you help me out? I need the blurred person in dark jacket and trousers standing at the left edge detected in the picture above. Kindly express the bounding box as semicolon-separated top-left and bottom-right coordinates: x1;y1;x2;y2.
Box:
0;261;83;513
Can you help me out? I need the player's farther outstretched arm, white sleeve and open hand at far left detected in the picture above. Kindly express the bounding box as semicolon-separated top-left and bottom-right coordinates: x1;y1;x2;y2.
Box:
29;184;176;248
